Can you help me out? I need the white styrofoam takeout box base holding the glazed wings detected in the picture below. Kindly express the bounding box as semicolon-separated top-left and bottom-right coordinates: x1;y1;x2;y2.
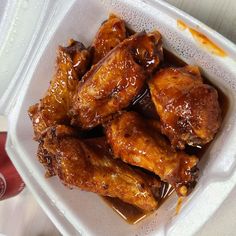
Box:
0;0;236;236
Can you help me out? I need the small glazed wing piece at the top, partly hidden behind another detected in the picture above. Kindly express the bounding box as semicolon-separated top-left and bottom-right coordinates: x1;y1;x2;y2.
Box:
91;15;126;64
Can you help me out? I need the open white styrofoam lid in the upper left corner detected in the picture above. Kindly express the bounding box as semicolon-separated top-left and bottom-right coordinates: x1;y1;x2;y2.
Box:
0;0;70;115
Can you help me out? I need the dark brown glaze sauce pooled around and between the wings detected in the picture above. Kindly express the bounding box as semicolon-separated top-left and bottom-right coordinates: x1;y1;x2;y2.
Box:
102;49;229;224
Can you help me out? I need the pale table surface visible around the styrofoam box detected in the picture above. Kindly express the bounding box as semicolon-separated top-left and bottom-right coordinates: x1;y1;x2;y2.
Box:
0;0;236;236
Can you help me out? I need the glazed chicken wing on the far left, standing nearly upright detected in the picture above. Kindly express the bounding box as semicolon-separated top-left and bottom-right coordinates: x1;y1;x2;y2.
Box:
28;40;90;140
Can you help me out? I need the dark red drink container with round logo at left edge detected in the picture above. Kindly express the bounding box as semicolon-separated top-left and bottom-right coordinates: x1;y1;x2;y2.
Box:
0;132;25;200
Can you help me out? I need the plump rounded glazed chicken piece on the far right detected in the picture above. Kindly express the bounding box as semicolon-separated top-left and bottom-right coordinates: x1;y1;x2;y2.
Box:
148;66;221;149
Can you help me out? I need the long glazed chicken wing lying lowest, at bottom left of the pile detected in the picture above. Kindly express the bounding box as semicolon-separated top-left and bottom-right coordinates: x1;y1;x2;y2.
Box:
43;125;162;211
